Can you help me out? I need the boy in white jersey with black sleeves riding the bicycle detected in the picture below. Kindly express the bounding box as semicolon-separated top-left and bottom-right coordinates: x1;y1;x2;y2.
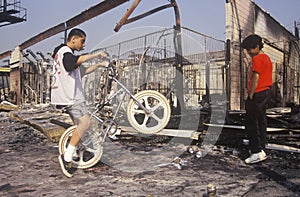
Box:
51;28;108;177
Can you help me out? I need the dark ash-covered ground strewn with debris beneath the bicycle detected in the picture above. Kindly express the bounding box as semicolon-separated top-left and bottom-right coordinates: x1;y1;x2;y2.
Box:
0;112;300;197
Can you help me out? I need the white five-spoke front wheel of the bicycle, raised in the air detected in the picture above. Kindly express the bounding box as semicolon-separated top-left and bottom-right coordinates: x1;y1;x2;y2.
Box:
127;90;171;134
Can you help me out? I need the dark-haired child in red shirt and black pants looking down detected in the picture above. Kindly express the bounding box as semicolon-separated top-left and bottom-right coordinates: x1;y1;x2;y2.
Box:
241;34;273;164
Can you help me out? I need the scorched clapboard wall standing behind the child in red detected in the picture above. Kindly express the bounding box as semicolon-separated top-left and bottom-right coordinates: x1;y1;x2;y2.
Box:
226;0;299;110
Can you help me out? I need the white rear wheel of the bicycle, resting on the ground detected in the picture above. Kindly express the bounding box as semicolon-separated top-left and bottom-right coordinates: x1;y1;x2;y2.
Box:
59;126;103;169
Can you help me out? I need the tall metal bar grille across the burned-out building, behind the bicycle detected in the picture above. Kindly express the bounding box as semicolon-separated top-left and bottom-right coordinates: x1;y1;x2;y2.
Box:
86;28;226;108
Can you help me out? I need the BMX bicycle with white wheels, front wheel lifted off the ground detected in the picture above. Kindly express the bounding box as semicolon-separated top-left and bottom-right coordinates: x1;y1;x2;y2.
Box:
59;61;171;169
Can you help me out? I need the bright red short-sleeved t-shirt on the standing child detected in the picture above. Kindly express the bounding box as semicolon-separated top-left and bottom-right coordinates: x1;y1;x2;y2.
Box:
248;53;273;92
